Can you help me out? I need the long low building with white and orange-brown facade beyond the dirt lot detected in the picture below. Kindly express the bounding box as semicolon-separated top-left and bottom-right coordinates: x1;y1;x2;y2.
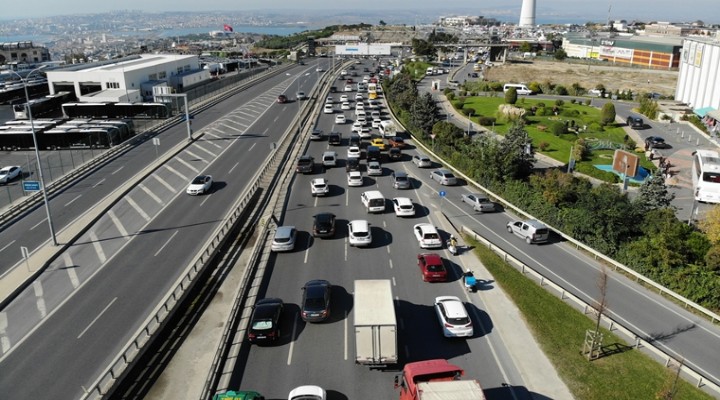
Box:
562;35;683;69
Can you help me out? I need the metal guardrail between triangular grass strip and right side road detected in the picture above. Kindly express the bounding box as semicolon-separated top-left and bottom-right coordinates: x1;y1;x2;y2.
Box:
462;226;720;396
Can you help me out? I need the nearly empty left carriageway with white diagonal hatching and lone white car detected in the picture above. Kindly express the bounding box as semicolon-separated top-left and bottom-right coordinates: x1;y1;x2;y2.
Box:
0;62;326;399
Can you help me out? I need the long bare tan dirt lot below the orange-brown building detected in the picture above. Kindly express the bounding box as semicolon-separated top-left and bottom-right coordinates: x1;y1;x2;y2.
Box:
485;61;678;96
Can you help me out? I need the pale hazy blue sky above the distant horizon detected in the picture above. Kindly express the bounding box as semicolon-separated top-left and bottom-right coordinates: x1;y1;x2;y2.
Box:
0;0;720;23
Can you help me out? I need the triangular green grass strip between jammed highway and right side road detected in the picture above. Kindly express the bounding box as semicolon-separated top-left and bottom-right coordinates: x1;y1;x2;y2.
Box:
466;238;712;400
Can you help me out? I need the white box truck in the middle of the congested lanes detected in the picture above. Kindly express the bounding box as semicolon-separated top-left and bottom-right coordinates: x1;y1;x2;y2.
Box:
353;279;398;369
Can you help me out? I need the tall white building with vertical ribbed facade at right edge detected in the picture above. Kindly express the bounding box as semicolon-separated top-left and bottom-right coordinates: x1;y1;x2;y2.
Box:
675;38;720;132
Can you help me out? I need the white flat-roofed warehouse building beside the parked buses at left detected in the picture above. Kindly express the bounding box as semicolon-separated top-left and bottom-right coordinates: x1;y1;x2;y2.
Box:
47;54;211;103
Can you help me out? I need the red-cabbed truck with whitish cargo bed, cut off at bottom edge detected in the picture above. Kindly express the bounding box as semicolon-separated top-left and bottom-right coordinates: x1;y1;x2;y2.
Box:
395;359;485;400
